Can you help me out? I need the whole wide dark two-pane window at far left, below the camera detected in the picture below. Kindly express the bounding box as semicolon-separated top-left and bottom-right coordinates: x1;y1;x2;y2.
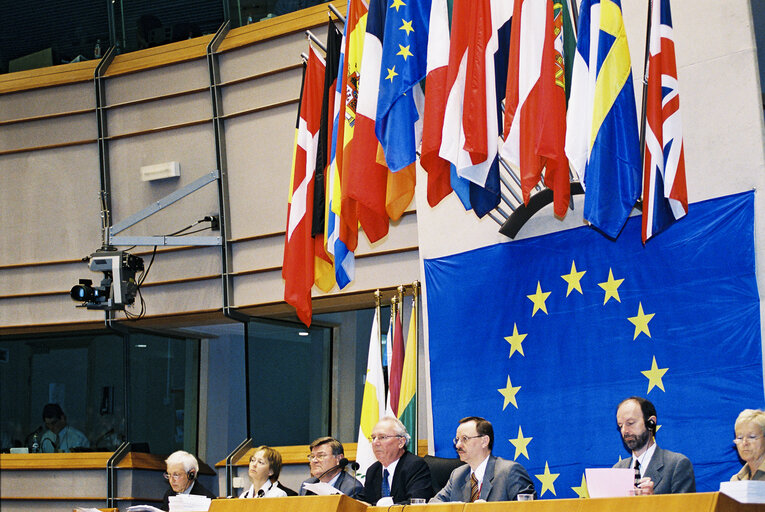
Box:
0;332;199;454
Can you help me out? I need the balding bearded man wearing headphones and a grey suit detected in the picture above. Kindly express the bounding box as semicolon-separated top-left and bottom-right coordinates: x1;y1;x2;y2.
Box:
614;396;696;494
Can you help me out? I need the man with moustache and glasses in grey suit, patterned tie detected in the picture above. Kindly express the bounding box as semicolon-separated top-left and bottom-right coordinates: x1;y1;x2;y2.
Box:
430;416;535;503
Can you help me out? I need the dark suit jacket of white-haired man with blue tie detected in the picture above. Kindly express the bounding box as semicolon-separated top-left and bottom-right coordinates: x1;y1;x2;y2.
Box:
358;452;433;505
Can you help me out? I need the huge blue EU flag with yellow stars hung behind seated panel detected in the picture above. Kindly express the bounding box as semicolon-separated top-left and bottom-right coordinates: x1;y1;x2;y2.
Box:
425;192;763;498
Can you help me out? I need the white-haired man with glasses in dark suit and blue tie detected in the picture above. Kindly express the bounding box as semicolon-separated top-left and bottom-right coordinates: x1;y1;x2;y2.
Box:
359;416;433;505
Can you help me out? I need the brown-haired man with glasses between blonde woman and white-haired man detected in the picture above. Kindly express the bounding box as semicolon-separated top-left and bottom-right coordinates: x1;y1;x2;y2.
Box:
300;437;364;498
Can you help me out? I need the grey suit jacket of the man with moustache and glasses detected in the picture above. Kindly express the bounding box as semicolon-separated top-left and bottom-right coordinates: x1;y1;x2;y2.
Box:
430;455;536;503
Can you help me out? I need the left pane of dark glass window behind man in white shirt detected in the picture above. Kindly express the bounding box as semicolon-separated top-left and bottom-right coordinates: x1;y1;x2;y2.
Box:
0;334;125;451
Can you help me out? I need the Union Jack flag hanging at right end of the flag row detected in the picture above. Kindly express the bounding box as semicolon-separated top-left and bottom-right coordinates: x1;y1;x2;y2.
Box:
643;0;688;243
